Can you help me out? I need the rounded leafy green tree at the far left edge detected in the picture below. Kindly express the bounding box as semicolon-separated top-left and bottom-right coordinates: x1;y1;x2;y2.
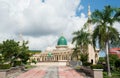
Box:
1;40;20;64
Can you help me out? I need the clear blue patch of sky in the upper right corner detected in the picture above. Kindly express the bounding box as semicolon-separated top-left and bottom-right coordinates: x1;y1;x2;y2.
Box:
78;0;120;15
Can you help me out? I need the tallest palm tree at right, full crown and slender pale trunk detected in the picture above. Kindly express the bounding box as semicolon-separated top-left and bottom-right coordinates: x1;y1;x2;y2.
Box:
91;6;120;76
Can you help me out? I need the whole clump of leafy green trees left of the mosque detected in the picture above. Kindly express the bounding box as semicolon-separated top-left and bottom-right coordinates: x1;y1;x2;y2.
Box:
0;40;30;66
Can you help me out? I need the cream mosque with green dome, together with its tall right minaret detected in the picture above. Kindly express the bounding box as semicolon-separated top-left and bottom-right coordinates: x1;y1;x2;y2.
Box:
32;6;99;64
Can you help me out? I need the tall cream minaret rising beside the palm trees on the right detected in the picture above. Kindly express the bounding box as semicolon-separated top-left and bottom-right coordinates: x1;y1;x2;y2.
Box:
88;5;96;64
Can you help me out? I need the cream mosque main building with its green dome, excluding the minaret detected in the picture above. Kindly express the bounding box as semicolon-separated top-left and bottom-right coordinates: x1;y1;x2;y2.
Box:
33;36;73;62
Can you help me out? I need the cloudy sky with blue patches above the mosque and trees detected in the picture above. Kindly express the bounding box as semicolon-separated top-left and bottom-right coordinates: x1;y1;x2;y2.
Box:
0;0;120;50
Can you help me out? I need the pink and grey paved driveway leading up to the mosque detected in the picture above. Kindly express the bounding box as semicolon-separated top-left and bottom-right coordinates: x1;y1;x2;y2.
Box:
16;63;85;78
